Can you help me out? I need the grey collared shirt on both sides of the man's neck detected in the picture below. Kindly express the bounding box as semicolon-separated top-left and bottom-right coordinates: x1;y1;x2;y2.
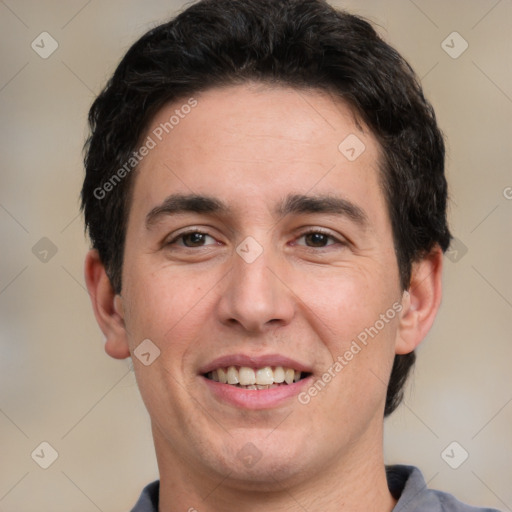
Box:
131;465;498;512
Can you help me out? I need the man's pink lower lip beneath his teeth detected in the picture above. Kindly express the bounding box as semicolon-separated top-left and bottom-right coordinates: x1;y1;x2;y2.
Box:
200;375;312;409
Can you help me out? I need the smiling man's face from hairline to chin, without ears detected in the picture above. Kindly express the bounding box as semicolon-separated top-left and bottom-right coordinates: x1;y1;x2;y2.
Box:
116;85;402;485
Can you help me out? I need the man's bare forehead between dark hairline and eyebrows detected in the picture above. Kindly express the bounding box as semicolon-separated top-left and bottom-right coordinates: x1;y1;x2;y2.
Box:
132;84;383;220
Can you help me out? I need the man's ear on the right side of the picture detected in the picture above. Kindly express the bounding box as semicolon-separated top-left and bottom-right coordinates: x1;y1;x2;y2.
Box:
395;246;443;354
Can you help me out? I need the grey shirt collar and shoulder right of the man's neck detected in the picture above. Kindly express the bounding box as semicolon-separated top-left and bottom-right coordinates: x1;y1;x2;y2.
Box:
386;465;499;512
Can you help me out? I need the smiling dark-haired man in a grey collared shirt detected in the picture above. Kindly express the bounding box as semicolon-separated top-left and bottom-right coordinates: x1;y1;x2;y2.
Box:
82;0;500;512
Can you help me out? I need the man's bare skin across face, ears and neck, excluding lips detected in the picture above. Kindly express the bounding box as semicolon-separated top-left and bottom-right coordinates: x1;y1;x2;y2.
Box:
85;84;442;512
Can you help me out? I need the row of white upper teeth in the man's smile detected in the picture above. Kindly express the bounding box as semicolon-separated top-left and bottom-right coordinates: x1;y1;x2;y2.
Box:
208;366;301;386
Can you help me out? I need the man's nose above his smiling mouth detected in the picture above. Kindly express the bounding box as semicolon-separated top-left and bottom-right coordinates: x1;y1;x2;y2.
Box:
218;246;295;333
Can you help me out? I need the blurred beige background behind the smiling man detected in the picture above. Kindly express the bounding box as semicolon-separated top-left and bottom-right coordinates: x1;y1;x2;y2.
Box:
0;0;512;512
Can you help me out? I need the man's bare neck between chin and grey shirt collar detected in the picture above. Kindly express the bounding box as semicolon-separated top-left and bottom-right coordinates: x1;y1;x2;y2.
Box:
153;429;396;512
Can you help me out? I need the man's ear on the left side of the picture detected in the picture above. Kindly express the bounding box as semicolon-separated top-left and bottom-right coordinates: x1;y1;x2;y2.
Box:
84;249;130;359
